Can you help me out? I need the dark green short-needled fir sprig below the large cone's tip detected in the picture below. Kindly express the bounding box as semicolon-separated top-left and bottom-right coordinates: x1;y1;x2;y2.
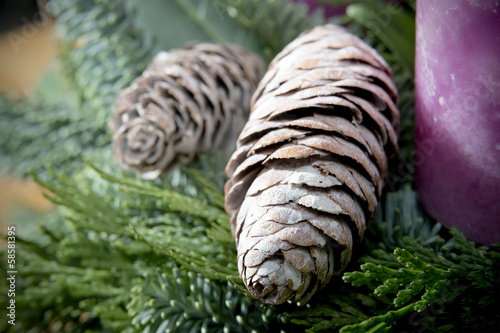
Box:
132;268;276;332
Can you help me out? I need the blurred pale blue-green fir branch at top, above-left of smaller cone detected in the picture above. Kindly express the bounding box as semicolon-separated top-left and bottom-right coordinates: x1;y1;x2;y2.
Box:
48;0;152;120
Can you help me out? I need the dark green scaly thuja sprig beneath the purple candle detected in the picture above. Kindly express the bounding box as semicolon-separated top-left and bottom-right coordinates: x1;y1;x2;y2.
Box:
341;228;500;332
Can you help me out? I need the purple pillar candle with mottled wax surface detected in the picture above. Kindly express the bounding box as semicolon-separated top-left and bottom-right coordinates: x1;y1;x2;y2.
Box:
415;0;500;244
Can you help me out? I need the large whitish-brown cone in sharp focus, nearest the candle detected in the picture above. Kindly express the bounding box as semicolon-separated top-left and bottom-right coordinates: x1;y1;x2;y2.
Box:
225;25;399;304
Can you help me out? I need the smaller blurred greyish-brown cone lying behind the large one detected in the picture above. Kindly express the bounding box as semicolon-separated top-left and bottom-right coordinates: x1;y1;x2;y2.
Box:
110;43;264;178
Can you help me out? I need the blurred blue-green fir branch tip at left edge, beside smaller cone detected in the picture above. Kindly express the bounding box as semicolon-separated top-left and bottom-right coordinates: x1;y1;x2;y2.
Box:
0;97;104;177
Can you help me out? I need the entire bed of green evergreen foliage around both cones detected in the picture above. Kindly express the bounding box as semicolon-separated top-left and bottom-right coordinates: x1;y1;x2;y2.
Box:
0;0;500;332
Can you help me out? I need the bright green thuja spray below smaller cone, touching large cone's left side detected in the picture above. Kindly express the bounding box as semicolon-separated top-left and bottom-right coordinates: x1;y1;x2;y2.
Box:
33;151;237;274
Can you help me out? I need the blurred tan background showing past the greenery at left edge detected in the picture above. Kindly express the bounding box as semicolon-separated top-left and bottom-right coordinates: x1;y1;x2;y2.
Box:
0;0;55;230
